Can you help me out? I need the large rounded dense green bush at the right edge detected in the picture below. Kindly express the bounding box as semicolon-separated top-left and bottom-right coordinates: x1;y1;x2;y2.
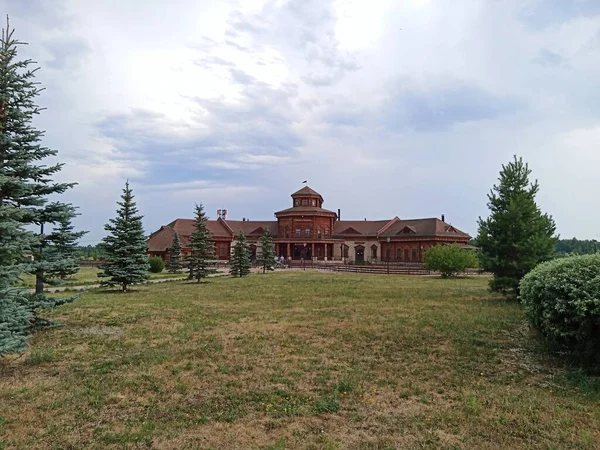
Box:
520;254;600;363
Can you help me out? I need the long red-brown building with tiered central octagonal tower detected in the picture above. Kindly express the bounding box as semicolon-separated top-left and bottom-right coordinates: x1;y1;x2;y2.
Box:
148;186;471;263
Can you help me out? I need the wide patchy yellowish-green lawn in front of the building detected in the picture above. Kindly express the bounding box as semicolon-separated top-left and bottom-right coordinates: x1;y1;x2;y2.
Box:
0;272;600;449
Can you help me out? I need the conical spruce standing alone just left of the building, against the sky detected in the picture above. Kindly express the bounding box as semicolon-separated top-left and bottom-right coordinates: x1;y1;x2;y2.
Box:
98;181;150;292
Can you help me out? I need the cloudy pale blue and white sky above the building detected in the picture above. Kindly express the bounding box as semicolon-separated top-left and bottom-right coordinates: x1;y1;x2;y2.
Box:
0;0;600;245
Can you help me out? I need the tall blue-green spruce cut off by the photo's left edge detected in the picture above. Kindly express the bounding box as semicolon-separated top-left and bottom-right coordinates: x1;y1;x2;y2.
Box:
0;19;81;354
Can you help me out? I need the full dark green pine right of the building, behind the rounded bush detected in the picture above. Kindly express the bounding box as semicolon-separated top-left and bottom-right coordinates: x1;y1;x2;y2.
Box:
477;156;557;295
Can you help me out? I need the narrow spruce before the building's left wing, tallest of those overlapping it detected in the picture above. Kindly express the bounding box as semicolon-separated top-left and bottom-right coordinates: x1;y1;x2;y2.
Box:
187;203;216;283
